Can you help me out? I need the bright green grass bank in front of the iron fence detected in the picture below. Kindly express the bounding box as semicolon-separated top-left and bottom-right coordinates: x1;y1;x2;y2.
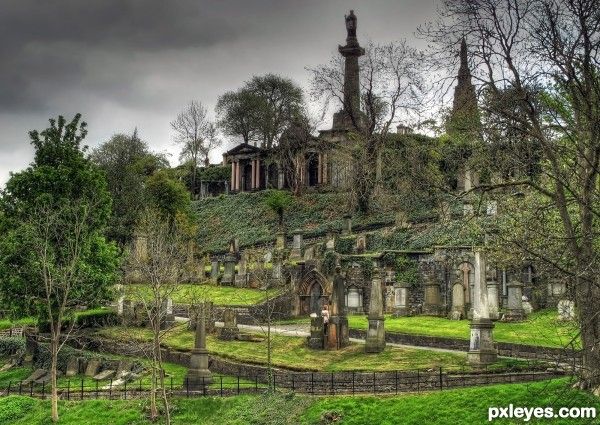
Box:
0;380;600;425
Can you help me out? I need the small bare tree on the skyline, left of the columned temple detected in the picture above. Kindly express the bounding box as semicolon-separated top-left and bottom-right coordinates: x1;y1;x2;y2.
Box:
171;101;221;193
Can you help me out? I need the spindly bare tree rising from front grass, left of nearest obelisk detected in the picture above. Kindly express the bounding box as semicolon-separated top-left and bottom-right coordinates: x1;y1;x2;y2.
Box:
128;209;190;424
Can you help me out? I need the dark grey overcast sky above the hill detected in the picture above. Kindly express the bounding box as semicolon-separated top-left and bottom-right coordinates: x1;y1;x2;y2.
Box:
0;0;436;186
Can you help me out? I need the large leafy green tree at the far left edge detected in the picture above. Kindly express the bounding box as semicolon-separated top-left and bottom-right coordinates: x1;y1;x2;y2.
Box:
0;114;118;422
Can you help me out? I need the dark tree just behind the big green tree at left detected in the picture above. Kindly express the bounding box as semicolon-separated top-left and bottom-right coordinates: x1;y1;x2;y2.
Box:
90;129;168;246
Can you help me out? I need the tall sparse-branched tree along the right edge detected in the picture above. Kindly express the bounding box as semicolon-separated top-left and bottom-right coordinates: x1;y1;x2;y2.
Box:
423;0;600;392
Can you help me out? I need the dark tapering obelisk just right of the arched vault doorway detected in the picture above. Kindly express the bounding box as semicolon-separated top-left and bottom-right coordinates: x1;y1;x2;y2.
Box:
325;267;350;350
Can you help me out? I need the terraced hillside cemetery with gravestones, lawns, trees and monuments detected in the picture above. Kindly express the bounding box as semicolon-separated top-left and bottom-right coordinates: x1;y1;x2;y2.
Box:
0;2;600;424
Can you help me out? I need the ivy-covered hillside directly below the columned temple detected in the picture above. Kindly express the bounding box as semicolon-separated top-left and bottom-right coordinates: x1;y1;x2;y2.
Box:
193;192;394;252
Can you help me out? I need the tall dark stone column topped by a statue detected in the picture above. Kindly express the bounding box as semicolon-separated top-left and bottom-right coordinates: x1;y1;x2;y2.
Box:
333;10;365;130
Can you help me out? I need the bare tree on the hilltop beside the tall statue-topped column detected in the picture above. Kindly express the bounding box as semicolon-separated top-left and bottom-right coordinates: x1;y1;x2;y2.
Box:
309;41;424;212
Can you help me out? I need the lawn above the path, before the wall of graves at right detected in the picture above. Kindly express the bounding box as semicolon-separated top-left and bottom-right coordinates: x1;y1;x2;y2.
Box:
279;309;577;347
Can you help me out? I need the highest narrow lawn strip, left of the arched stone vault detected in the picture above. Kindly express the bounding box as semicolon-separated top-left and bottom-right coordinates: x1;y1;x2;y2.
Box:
124;284;276;305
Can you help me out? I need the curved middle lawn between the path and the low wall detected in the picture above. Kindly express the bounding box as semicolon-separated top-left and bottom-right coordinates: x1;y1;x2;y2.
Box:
98;327;522;372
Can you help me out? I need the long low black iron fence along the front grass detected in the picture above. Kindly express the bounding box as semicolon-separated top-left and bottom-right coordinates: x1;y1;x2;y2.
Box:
0;368;564;400
